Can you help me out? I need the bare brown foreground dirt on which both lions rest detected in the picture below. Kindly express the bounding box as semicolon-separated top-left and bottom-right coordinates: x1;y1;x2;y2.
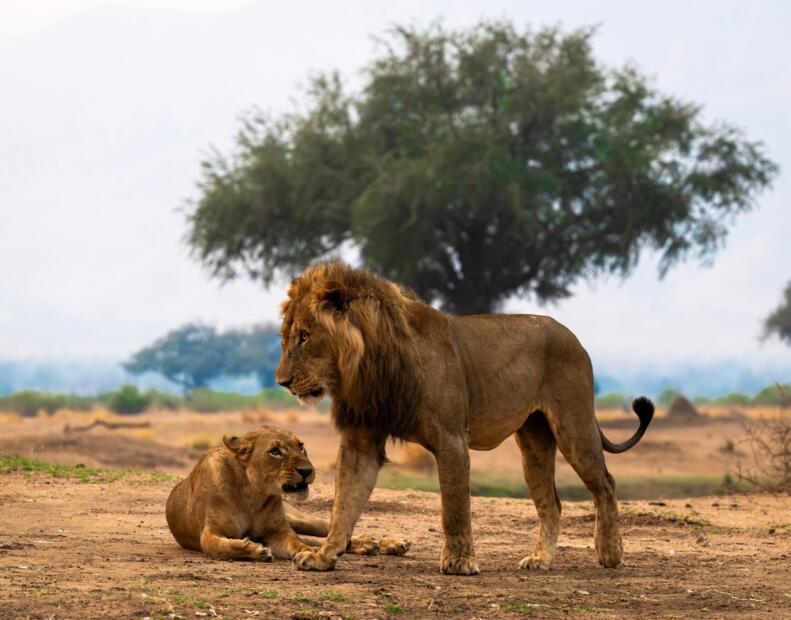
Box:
0;472;791;618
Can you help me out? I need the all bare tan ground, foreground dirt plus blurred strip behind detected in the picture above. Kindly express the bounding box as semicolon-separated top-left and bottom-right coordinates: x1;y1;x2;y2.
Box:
0;411;791;618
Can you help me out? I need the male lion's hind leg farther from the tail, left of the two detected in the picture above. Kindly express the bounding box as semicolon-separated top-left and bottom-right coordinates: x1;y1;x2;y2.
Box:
516;411;561;570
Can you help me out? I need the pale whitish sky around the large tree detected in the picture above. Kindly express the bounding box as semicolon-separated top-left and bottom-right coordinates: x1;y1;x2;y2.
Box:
0;0;791;367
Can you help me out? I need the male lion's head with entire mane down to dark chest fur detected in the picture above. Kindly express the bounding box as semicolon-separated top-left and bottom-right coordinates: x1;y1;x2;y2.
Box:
276;261;418;446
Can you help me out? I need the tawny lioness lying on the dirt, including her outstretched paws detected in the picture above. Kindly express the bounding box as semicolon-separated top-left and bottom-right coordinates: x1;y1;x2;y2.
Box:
166;426;409;562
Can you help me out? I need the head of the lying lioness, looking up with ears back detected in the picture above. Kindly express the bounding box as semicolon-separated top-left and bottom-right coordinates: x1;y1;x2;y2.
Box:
222;426;316;495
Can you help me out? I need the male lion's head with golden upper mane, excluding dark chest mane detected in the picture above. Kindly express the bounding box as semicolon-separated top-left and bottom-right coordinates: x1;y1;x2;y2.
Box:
275;262;415;404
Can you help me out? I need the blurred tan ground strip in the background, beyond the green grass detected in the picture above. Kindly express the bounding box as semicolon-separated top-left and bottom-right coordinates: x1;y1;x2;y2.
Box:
0;409;772;484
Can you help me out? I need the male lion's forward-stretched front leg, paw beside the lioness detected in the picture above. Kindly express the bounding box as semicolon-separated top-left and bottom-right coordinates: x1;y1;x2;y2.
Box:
294;431;382;570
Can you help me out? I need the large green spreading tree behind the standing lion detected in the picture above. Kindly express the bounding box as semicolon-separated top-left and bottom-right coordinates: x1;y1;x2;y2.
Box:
188;22;776;313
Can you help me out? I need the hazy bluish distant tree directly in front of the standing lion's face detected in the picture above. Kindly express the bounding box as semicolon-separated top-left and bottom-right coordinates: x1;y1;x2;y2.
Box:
223;325;280;388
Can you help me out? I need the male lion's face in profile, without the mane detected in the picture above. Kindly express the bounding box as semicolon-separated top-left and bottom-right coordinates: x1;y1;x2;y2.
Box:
275;304;339;405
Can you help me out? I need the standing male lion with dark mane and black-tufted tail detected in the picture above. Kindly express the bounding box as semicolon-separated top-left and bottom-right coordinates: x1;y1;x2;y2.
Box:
277;262;654;575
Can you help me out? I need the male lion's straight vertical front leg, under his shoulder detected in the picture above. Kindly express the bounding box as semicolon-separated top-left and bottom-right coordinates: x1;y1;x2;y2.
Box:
434;438;481;575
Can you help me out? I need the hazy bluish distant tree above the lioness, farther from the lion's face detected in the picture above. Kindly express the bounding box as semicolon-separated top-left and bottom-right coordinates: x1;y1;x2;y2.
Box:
123;324;229;391
